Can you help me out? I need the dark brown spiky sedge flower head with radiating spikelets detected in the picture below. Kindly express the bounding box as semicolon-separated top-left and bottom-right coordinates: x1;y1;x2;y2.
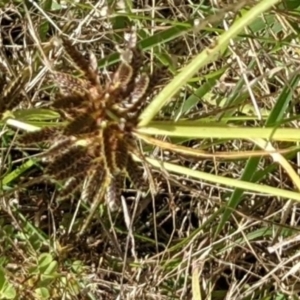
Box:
19;31;162;207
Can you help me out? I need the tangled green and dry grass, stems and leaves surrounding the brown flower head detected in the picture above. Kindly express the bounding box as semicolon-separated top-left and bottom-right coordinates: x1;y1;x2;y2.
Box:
0;0;300;300
